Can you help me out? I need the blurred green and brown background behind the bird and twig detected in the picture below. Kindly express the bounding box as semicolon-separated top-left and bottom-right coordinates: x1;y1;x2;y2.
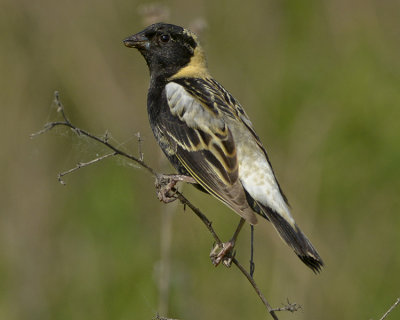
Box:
0;0;400;320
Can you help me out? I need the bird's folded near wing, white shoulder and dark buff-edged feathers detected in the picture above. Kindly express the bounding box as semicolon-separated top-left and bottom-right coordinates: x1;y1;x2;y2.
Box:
157;82;257;224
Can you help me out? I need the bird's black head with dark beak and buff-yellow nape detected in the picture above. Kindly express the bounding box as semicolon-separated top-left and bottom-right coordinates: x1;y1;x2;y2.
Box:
124;23;208;80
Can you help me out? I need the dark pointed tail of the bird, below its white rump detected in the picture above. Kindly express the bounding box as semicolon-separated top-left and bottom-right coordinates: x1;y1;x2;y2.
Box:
258;203;324;273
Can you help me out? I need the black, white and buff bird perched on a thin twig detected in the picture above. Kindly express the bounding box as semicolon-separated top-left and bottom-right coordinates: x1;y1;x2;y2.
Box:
123;22;324;273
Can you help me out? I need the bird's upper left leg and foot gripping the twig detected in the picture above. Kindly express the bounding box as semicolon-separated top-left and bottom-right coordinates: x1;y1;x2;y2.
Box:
155;174;197;203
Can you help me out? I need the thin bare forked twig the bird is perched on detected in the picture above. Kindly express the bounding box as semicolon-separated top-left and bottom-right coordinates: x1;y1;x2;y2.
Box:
31;91;295;320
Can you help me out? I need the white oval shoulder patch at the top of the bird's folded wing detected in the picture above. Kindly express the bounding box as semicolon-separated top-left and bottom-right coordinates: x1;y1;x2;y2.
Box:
165;82;225;132
